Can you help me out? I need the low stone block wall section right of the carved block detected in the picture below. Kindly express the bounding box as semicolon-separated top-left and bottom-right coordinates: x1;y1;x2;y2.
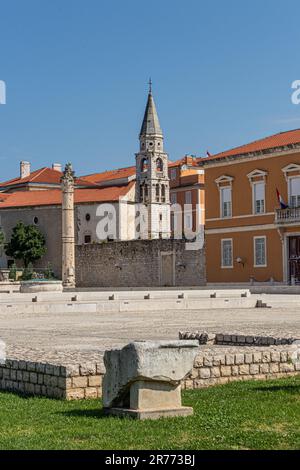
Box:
183;346;300;389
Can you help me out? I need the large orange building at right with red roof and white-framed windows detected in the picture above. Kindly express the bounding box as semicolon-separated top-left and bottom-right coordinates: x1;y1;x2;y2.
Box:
199;130;300;284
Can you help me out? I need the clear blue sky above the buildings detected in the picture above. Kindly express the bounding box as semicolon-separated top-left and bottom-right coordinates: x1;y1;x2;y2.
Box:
0;0;300;181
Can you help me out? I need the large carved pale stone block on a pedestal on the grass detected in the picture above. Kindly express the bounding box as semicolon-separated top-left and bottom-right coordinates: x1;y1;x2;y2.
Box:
103;341;199;419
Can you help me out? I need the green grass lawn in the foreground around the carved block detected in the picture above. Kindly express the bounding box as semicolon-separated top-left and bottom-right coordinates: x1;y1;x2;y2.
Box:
0;377;300;450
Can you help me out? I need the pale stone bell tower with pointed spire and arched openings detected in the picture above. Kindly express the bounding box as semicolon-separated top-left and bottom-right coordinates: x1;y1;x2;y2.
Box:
136;80;170;238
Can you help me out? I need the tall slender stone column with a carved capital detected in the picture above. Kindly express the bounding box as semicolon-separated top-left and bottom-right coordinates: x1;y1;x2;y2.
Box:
61;163;75;288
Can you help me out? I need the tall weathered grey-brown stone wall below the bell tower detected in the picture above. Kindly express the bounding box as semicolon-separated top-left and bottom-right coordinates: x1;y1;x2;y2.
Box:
76;240;206;288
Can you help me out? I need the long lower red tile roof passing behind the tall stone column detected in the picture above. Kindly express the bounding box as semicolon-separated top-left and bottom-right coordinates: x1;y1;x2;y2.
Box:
0;182;134;209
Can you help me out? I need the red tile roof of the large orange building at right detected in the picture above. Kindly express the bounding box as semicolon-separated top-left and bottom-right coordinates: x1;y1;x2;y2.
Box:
198;129;300;164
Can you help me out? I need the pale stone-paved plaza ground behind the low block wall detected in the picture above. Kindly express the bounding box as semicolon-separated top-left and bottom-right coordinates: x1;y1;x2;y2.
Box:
0;307;300;364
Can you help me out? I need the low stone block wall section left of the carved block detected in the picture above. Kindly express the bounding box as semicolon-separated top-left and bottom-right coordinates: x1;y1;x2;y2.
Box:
0;359;103;400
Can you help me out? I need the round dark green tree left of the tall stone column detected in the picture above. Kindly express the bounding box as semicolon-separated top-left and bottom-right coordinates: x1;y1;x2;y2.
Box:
5;222;46;268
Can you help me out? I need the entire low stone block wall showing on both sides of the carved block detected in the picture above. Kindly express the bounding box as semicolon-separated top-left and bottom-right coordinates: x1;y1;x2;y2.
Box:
0;346;300;400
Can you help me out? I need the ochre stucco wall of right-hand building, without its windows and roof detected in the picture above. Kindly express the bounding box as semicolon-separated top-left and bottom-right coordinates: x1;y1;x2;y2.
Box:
204;152;300;282
